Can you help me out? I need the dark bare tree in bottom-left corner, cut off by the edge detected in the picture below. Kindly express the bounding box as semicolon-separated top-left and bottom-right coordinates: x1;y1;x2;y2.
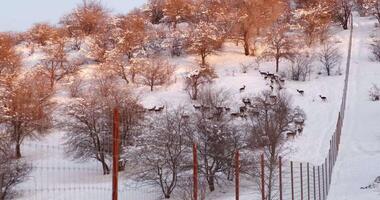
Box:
0;133;31;200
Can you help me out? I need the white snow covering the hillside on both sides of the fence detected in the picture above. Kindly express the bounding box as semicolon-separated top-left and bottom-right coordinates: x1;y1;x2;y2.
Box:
12;13;380;200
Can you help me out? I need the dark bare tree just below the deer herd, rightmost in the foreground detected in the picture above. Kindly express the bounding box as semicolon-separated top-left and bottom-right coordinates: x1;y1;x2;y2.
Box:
248;91;305;199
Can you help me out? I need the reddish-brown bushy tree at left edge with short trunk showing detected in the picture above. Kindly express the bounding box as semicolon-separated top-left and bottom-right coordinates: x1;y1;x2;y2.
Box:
0;71;53;158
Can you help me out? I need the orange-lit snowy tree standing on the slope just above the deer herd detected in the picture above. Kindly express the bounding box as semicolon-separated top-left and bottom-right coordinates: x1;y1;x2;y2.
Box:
265;23;293;73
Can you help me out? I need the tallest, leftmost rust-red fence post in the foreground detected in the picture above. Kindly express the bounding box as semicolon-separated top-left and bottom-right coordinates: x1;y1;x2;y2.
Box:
112;108;120;200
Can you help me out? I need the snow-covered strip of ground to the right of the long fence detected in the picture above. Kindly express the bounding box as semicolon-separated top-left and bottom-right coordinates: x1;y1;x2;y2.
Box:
329;14;380;200
